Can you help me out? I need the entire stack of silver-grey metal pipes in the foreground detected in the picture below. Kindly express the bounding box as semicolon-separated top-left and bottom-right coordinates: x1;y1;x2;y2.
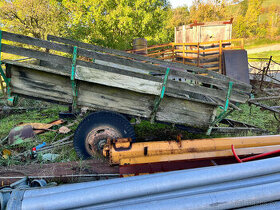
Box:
3;157;280;210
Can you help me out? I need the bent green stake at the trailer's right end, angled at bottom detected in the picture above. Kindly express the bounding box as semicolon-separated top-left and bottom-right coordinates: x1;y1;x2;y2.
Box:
206;81;233;135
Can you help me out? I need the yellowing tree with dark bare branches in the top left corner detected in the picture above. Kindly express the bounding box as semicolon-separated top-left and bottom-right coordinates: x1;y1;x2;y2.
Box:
0;0;65;39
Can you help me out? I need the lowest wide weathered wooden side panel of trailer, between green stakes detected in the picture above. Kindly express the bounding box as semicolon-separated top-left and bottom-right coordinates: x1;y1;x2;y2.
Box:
10;64;216;129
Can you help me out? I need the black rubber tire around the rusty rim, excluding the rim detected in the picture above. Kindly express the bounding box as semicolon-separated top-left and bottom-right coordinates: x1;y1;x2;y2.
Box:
73;111;135;159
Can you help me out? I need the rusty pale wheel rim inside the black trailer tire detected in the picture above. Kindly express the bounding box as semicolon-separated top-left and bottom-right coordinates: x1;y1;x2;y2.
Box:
85;125;122;156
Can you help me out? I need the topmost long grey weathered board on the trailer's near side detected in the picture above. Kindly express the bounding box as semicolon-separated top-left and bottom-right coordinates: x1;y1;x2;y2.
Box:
3;31;250;91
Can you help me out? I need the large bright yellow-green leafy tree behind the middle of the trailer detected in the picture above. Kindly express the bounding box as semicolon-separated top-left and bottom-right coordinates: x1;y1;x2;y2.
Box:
62;0;170;49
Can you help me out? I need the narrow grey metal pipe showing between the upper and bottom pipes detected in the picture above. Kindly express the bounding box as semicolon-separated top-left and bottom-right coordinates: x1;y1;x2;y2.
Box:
85;173;280;209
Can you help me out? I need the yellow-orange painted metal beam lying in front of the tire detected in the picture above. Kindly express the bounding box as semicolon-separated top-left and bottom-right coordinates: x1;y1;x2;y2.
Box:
103;135;280;164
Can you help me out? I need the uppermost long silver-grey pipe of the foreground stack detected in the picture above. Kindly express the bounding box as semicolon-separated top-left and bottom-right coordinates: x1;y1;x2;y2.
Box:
19;157;280;210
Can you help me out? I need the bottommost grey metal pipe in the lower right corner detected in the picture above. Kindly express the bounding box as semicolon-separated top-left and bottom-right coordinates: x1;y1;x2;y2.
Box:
103;182;280;210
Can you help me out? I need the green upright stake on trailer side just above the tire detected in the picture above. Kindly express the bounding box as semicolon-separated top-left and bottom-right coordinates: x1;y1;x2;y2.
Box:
71;46;78;110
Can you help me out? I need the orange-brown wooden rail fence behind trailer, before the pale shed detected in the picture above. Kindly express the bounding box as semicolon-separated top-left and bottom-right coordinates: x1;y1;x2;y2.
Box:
128;39;244;73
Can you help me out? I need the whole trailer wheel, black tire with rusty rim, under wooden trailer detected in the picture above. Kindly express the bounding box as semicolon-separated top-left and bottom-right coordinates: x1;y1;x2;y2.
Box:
74;111;135;159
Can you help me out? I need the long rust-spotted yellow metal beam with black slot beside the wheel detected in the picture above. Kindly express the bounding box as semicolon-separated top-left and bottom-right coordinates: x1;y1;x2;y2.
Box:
103;135;280;165
